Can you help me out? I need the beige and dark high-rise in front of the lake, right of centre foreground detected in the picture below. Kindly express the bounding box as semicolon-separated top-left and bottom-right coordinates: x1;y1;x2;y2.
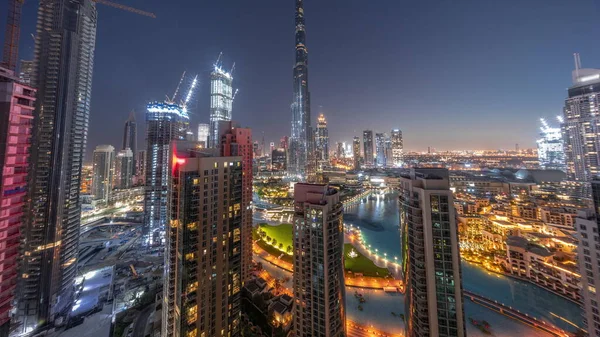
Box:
400;168;466;337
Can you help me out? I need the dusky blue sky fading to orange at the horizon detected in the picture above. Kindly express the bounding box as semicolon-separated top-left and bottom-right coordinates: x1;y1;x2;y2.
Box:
0;0;600;158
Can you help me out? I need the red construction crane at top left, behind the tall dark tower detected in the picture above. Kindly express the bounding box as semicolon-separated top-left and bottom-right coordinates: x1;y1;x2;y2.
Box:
0;0;156;71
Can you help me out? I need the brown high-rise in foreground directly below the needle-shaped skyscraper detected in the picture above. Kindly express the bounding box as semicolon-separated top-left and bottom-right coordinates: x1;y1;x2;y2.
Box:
293;183;346;337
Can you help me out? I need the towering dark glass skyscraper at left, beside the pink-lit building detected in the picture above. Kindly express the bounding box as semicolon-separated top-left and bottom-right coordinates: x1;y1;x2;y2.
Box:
15;0;97;331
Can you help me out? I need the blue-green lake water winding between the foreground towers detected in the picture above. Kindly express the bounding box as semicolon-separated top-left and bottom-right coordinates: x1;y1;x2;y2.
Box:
344;194;583;331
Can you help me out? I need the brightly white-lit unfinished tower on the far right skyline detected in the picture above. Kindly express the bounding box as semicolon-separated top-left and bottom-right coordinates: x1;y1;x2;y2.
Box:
537;119;566;171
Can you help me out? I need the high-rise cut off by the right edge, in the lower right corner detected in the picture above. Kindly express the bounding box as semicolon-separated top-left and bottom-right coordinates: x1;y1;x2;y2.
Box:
575;180;600;337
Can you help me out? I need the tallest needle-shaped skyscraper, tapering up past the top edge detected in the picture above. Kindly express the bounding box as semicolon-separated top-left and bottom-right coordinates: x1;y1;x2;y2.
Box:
288;0;313;176
